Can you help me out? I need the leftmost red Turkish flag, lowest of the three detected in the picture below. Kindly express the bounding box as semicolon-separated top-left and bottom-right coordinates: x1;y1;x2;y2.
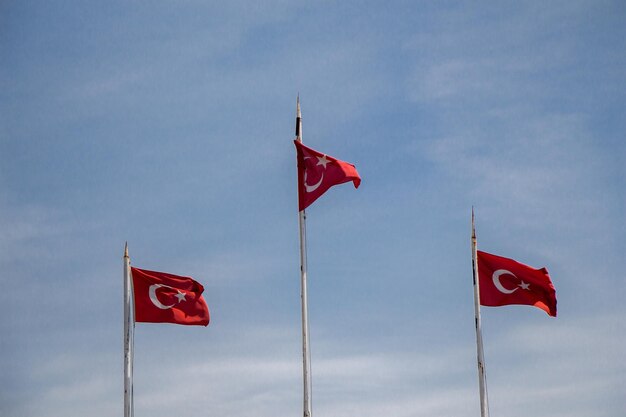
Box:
131;268;209;326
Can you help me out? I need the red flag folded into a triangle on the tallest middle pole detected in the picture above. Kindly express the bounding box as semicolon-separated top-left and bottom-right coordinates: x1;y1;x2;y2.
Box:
294;140;361;211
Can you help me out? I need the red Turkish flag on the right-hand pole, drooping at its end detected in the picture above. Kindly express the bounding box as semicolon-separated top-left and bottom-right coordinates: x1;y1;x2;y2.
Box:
478;251;556;317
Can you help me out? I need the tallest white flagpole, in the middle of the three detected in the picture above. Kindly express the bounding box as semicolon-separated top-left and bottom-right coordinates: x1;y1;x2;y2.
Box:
296;94;312;417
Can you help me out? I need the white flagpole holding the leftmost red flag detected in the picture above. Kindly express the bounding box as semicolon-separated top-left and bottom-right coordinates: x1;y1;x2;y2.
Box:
124;243;134;417
